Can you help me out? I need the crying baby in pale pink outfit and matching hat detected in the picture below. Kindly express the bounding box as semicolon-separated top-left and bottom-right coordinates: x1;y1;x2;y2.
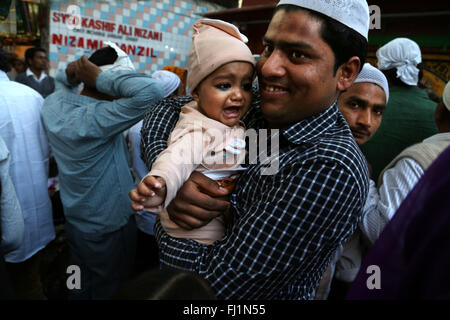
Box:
135;19;255;244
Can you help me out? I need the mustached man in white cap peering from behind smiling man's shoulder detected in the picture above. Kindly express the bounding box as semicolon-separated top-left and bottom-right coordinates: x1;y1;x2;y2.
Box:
315;63;389;300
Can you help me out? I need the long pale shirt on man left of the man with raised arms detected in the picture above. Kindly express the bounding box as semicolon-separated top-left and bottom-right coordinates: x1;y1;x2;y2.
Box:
0;71;55;263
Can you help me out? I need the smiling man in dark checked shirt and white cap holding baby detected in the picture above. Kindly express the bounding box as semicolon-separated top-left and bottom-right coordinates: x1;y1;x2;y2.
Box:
130;0;369;300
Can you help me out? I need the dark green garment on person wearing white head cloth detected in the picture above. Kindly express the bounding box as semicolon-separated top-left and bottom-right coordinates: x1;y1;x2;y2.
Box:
361;86;438;185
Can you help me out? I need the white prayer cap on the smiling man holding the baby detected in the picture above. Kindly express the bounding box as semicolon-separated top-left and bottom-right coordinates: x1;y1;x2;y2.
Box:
278;0;370;40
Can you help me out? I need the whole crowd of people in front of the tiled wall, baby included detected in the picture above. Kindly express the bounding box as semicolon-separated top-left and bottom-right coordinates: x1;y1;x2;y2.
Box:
0;0;450;300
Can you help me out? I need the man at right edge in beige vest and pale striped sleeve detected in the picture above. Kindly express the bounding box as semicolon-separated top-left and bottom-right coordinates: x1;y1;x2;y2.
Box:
328;81;450;300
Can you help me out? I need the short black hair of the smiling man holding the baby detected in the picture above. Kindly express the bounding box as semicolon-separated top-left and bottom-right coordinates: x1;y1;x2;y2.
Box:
274;4;368;74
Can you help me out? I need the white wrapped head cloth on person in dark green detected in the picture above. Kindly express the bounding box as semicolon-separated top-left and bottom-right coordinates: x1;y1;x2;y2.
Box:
377;38;422;86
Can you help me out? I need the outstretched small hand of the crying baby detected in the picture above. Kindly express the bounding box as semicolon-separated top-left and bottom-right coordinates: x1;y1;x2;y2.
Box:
130;176;167;212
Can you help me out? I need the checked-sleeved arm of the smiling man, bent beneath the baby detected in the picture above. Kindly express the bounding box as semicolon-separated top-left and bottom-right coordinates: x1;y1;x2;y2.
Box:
155;162;364;299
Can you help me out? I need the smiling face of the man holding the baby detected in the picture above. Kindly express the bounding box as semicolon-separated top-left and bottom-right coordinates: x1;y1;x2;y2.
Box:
257;10;338;128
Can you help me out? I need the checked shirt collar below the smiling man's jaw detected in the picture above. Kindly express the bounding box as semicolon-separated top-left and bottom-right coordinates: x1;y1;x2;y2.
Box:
281;100;338;144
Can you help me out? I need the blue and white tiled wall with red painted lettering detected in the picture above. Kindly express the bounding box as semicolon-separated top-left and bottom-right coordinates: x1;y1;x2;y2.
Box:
49;0;223;76
